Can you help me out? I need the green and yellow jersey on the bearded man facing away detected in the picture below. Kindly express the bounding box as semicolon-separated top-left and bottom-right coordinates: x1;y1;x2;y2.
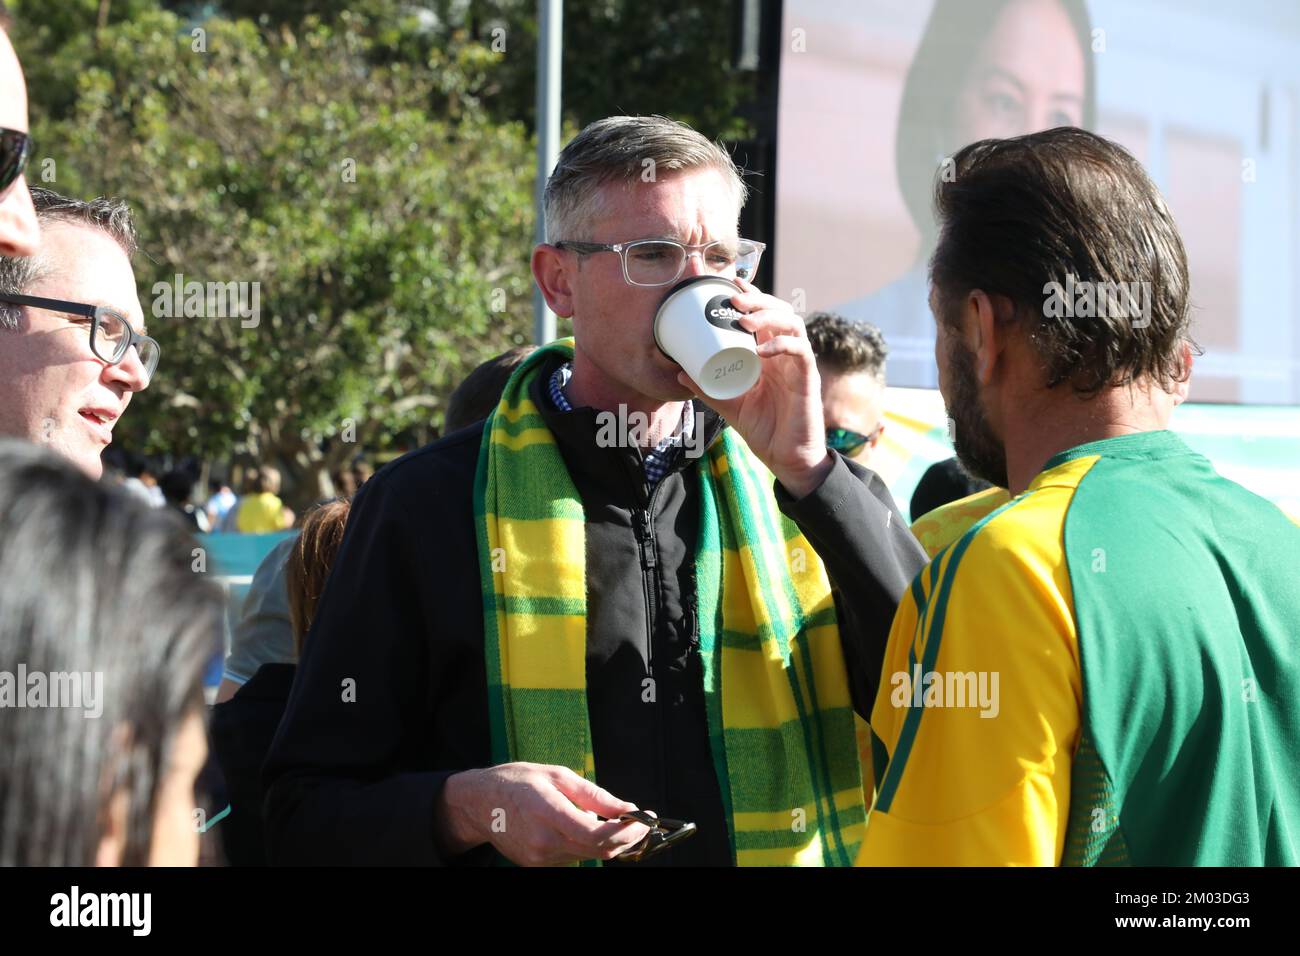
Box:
858;432;1300;866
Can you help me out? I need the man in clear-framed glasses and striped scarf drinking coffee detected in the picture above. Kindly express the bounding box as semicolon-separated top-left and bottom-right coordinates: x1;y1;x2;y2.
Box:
267;111;924;865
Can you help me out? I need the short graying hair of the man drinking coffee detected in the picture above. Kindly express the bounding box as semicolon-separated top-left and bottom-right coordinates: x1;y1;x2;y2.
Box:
543;116;746;242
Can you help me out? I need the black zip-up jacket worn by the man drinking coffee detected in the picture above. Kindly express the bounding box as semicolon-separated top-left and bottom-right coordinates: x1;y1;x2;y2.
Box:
264;358;926;866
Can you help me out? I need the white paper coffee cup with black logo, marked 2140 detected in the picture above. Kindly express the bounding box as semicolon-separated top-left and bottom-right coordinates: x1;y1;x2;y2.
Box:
654;276;759;401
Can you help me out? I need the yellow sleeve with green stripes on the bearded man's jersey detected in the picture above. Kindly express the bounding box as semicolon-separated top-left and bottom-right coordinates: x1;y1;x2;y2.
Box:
858;488;1082;866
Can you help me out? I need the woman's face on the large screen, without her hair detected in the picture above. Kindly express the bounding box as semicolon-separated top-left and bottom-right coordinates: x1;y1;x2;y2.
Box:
953;0;1089;148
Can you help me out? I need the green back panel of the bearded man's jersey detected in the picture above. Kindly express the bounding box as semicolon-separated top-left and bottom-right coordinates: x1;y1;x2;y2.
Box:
1048;432;1300;866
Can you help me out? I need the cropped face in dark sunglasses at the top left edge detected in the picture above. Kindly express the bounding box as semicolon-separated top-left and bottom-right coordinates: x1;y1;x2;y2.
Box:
0;3;40;259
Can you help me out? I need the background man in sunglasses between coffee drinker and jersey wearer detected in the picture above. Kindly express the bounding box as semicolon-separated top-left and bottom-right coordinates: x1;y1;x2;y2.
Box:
807;312;889;468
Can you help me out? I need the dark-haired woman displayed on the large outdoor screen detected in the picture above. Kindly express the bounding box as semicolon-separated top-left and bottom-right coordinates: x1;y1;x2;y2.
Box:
840;0;1096;386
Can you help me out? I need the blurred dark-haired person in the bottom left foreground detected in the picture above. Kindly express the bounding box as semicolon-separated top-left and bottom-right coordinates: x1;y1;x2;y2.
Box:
0;440;224;866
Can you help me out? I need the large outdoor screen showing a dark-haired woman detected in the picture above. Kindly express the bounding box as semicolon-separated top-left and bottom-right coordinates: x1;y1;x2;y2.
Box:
774;0;1300;405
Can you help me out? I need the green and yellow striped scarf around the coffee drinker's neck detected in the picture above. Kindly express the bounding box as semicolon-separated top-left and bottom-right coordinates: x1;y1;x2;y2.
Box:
475;339;866;866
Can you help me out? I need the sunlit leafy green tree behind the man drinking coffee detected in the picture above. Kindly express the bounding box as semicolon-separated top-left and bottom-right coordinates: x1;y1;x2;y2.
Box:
14;3;534;505
